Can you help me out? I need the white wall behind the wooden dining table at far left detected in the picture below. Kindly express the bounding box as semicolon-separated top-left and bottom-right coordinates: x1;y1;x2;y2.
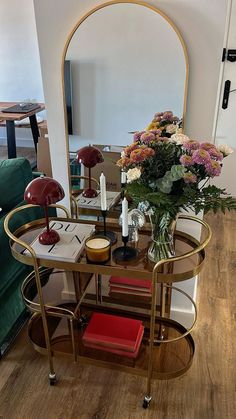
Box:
0;0;44;147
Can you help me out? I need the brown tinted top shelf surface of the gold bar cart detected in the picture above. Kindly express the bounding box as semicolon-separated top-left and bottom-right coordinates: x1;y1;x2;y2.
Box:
8;215;210;283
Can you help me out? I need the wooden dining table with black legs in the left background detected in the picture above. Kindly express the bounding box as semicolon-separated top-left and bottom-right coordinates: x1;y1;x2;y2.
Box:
0;102;45;159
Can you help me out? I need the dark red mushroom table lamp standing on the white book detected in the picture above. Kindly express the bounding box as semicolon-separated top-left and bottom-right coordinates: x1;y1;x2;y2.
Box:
24;176;65;244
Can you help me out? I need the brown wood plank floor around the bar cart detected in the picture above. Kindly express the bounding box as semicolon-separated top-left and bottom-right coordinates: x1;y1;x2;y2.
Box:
0;213;236;419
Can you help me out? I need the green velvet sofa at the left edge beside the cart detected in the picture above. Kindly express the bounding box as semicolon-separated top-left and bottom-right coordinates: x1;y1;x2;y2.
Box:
0;158;55;357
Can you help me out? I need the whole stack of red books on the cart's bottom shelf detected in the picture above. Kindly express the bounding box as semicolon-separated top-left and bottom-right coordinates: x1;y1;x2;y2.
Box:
82;313;144;358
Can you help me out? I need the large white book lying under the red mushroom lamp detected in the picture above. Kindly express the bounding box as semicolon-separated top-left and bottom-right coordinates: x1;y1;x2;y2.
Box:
24;220;95;262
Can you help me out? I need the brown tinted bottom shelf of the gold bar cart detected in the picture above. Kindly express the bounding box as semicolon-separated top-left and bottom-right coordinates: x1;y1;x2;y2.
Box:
28;307;195;380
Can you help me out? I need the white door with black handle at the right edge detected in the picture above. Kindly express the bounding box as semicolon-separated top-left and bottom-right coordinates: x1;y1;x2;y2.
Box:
213;0;236;196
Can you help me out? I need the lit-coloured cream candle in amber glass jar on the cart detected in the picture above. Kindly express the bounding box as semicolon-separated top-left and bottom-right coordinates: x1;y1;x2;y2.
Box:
85;236;111;263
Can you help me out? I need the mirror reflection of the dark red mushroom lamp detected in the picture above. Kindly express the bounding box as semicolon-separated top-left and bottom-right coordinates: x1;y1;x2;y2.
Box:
76;145;104;198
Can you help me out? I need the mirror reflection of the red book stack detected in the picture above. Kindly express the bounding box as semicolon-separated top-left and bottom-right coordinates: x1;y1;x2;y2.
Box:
109;276;152;298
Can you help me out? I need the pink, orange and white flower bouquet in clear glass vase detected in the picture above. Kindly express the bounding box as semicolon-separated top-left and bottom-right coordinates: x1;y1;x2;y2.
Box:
117;111;236;262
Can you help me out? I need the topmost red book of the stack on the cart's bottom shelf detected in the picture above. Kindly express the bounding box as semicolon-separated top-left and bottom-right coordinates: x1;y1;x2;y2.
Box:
82;313;143;352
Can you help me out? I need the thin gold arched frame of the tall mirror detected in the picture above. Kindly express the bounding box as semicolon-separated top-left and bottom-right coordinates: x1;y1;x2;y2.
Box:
61;0;189;210
